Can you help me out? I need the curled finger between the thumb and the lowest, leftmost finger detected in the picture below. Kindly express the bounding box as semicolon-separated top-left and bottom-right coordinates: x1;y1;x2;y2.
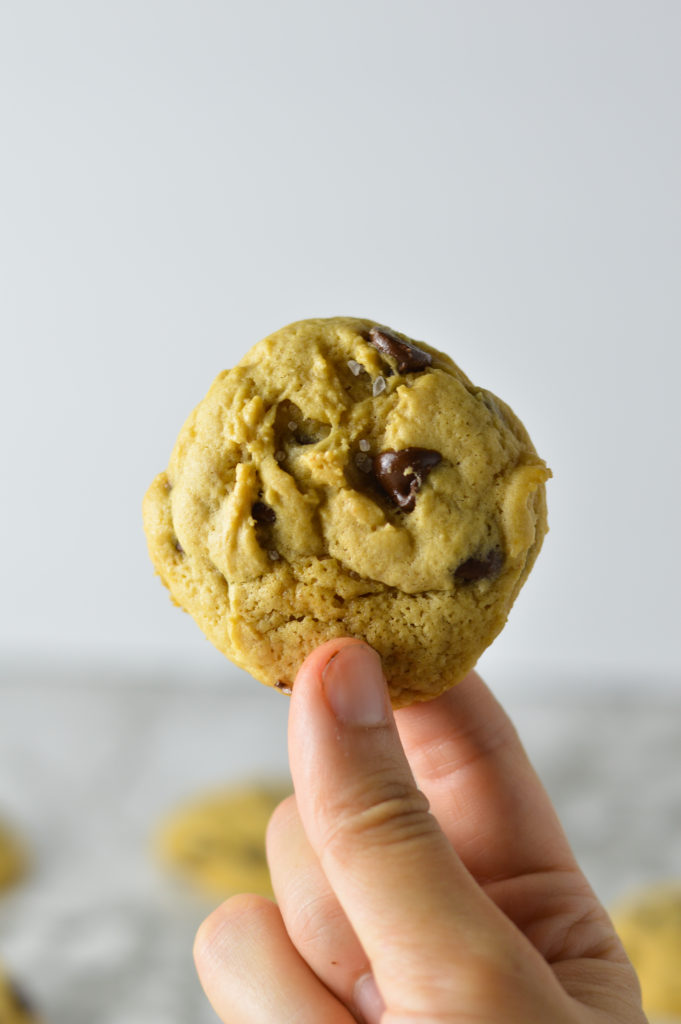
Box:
267;797;383;1024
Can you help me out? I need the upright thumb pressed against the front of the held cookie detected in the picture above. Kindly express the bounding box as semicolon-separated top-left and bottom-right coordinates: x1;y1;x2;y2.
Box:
289;640;512;1014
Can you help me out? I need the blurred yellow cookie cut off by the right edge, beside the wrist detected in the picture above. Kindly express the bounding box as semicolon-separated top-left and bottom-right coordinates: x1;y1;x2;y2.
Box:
612;882;681;1021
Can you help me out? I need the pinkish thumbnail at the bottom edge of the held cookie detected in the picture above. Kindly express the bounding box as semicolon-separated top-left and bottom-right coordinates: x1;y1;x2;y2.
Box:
322;643;390;725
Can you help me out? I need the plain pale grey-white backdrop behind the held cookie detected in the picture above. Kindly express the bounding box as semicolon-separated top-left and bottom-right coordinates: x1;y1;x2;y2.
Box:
0;0;681;687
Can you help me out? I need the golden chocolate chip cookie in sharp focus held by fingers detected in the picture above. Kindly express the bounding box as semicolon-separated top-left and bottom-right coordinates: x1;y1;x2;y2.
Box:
143;316;551;707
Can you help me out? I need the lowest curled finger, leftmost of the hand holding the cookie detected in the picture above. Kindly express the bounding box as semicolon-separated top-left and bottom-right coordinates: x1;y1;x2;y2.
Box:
194;896;353;1024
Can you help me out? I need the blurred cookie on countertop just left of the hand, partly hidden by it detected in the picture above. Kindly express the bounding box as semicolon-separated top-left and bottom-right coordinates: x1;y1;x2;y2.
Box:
155;784;290;899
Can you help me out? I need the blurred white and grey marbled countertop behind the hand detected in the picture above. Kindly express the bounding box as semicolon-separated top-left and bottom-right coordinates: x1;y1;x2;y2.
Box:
0;672;681;1024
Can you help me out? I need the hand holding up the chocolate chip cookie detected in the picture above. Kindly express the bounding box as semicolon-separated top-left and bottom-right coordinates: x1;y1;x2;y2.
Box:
195;640;645;1024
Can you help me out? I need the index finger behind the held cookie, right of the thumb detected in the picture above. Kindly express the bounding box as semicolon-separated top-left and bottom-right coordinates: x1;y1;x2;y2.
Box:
395;672;576;884
